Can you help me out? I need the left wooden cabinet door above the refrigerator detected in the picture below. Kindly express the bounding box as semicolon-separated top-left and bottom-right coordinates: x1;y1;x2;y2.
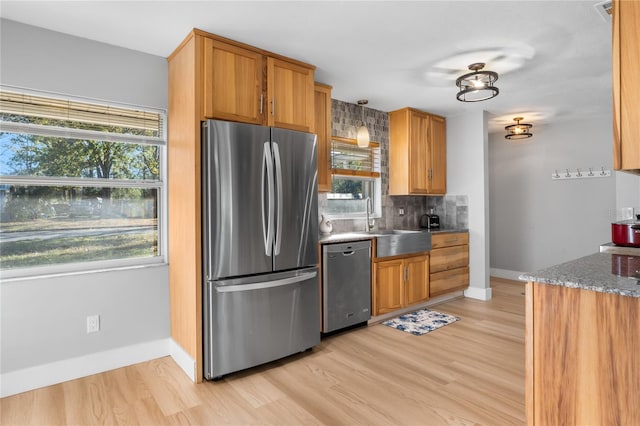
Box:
203;38;264;124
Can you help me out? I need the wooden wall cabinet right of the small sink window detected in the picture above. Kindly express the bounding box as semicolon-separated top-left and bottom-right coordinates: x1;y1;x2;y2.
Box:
389;108;447;195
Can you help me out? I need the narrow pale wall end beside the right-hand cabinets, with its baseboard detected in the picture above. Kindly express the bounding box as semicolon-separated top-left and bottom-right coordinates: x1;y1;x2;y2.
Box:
447;110;493;300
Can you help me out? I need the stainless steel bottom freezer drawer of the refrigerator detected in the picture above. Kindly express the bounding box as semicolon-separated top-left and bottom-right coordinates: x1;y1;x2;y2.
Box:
204;267;320;379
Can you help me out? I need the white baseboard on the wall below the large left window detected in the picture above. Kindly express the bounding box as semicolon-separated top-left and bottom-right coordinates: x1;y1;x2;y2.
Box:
0;338;171;398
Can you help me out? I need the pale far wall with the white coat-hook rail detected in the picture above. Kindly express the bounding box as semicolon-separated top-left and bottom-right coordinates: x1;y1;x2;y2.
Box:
489;115;616;278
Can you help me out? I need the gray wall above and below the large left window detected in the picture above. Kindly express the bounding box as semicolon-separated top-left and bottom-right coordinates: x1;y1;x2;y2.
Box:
0;20;170;374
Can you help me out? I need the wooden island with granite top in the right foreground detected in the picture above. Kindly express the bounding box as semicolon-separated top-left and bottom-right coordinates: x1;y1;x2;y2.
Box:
520;253;640;425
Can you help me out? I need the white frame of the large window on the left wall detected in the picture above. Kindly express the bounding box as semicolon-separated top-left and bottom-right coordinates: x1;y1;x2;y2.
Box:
0;85;168;281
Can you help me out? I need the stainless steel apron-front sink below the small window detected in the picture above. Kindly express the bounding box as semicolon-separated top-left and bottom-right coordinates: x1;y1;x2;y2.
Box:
356;229;431;257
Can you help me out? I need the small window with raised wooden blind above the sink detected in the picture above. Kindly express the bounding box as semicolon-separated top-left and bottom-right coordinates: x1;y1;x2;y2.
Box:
327;137;381;218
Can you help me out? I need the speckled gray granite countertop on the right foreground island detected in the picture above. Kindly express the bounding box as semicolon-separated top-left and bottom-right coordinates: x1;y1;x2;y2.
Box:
520;253;640;297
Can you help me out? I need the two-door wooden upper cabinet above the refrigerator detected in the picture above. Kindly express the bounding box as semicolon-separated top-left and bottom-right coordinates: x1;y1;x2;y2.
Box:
180;30;315;132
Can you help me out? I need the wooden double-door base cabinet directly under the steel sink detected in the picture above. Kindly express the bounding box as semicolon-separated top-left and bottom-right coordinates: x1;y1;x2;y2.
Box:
373;254;429;316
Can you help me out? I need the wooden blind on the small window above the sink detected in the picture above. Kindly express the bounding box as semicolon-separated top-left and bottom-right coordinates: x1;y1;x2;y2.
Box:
331;136;380;178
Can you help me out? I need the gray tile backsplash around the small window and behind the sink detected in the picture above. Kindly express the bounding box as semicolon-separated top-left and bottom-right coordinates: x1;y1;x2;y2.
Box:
318;99;469;233
